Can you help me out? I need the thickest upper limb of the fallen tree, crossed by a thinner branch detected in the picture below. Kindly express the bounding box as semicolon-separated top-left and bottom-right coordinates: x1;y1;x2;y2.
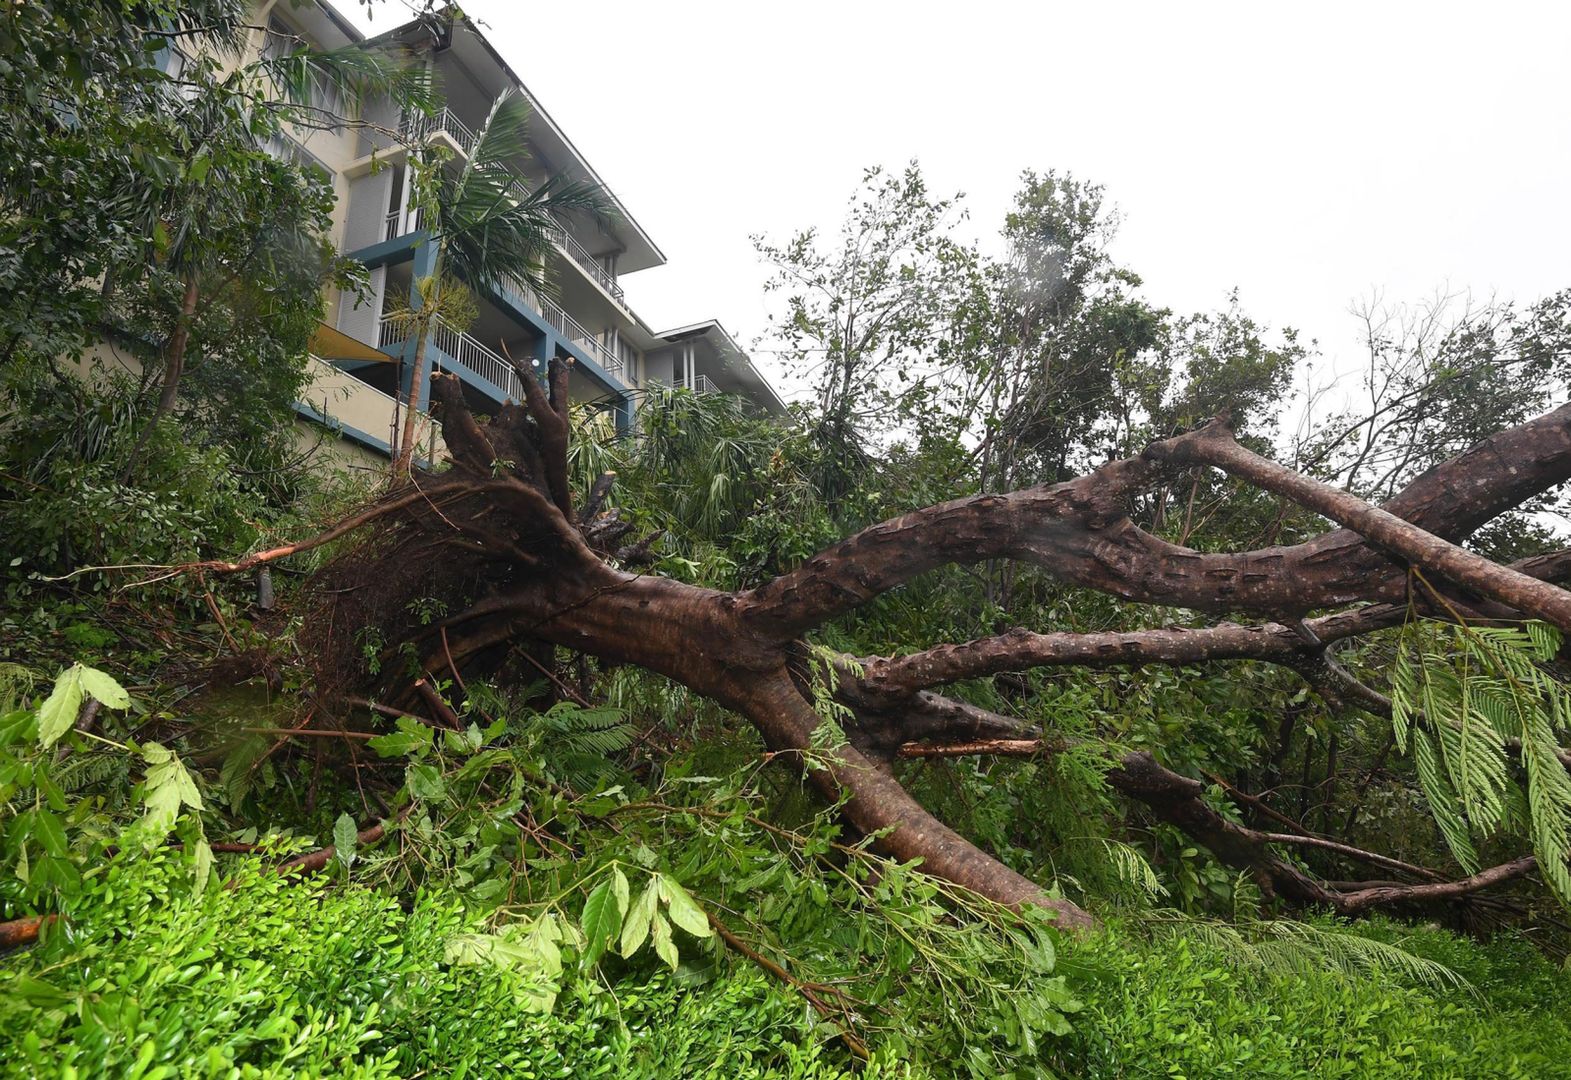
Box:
738;406;1571;641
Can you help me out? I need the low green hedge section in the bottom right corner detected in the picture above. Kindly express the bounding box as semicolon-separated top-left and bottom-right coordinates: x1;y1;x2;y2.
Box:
1059;923;1571;1080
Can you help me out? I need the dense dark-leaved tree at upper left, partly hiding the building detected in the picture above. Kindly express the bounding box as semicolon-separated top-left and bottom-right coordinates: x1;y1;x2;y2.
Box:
0;0;429;476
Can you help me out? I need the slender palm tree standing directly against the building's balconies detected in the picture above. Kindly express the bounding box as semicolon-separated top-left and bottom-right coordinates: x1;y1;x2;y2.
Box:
391;90;610;481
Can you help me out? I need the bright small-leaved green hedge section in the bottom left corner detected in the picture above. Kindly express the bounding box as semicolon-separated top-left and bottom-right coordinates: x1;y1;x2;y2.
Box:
0;852;914;1080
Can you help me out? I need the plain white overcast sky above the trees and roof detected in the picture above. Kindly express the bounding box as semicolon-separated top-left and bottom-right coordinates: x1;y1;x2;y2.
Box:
344;0;1571;400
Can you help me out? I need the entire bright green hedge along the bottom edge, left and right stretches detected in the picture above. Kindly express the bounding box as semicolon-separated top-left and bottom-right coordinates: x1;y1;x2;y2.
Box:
0;852;1571;1080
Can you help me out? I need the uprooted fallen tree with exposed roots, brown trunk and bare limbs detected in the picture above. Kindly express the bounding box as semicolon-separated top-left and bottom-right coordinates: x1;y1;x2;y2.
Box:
221;363;1571;926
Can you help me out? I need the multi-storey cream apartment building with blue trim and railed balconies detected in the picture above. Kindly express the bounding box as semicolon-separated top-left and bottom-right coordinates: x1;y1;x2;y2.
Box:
240;0;784;465
